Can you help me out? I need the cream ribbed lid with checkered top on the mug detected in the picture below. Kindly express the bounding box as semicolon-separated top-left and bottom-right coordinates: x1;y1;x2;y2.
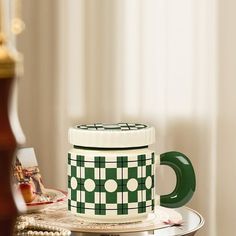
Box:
69;123;155;148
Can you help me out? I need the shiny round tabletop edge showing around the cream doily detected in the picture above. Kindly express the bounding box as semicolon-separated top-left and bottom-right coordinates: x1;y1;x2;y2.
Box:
69;207;204;236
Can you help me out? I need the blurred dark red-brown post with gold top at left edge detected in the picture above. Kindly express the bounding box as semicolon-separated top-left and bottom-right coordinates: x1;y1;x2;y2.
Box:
0;36;18;236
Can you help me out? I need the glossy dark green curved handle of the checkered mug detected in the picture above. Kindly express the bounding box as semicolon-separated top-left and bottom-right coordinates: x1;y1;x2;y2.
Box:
160;151;196;208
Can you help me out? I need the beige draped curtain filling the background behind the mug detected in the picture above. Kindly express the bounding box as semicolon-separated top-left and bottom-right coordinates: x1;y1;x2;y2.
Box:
18;0;236;236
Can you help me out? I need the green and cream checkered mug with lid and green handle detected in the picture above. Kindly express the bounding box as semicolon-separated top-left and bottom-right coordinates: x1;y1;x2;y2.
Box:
68;123;196;222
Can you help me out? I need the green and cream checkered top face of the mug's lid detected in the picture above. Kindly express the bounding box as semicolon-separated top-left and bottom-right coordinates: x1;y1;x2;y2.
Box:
77;123;147;131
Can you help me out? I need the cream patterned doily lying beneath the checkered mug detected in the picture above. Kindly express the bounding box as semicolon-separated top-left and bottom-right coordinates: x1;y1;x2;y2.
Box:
27;202;182;233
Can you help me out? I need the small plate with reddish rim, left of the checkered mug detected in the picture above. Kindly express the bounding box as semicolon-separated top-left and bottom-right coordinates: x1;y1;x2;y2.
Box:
26;189;66;212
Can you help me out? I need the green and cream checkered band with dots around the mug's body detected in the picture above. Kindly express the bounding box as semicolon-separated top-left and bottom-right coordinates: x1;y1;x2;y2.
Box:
68;153;154;215
